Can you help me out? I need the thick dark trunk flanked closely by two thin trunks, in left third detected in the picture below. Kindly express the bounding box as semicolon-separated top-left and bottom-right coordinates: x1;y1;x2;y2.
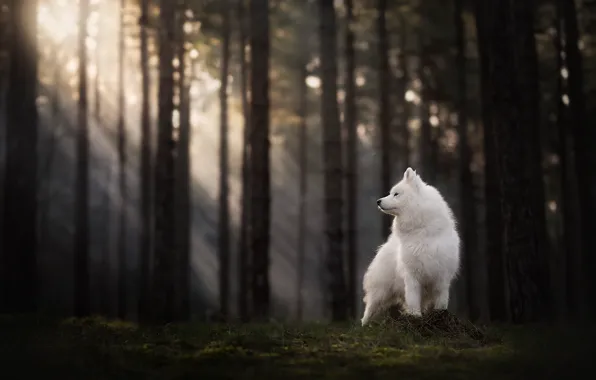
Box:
151;0;177;323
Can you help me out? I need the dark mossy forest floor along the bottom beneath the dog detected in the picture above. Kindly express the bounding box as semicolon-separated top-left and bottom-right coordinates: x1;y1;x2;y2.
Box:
0;317;596;380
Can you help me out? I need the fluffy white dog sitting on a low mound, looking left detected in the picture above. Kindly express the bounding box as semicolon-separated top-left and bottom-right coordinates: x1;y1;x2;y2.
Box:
361;168;460;326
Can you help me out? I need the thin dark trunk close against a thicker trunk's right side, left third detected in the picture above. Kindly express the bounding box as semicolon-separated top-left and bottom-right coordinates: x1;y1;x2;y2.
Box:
176;4;192;320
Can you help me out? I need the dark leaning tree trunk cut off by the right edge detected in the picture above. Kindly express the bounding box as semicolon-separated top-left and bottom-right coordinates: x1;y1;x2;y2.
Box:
563;1;596;317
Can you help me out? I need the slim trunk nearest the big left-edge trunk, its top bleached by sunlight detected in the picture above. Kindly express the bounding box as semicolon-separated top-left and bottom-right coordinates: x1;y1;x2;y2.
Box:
74;0;90;317
